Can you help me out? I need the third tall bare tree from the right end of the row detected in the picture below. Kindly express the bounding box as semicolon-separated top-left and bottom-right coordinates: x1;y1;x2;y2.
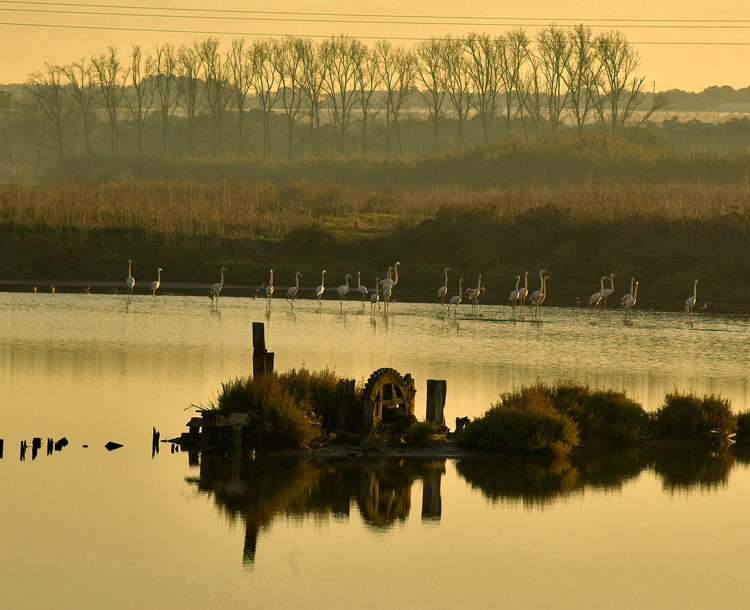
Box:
537;25;572;133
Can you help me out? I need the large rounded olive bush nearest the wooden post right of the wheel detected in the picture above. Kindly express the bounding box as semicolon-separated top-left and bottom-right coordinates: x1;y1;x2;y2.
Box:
459;386;579;458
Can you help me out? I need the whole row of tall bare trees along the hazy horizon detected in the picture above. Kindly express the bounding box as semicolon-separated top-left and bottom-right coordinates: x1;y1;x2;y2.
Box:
22;25;663;159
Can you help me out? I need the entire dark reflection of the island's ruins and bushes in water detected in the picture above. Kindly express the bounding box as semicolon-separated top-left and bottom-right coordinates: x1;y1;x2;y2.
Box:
186;447;750;564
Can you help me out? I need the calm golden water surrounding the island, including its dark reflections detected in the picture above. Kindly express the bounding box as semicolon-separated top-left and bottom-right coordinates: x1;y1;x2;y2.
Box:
0;293;750;609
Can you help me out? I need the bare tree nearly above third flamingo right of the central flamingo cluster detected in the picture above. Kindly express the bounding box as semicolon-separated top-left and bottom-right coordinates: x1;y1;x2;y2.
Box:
464;33;502;146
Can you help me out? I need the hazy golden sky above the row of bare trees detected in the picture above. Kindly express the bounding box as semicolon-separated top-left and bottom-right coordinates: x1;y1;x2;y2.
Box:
0;0;750;91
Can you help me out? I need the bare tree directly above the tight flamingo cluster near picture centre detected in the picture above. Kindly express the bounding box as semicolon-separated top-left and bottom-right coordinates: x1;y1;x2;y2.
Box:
375;40;415;158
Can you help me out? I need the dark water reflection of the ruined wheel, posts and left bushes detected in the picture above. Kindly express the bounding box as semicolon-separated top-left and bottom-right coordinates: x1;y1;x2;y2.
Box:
187;454;445;563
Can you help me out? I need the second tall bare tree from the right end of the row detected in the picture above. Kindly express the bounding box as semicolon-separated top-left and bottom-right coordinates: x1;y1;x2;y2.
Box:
562;24;601;135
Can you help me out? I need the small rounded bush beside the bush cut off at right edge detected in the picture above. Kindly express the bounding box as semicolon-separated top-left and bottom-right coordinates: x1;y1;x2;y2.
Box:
652;392;737;441
